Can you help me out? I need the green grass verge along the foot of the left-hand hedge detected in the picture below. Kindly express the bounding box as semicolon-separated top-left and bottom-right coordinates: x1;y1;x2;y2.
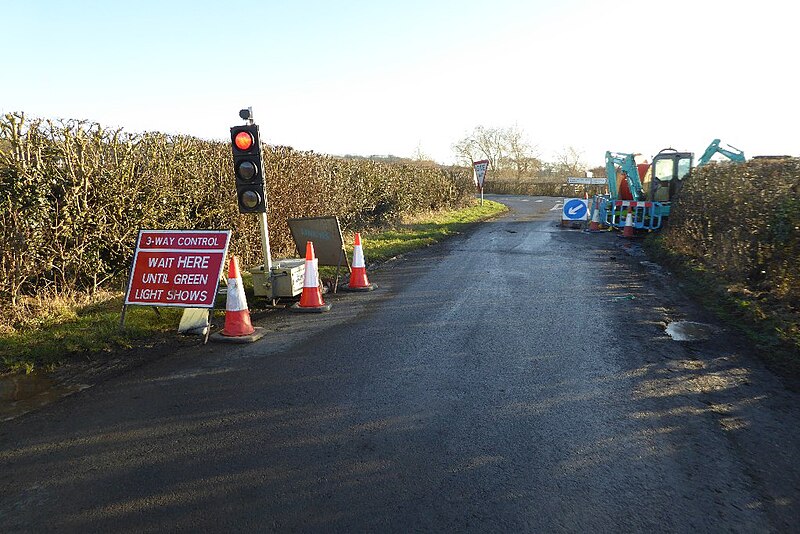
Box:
0;200;507;373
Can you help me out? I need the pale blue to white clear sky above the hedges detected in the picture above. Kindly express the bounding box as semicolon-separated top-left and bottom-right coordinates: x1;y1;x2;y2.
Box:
0;0;800;165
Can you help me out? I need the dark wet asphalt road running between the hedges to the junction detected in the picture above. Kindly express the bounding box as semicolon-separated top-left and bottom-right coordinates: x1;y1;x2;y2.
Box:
0;197;800;532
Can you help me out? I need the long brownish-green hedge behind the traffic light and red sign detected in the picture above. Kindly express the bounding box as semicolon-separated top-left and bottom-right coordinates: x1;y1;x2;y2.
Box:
0;114;474;304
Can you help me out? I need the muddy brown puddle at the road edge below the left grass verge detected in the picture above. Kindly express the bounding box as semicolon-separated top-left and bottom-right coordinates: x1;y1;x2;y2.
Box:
0;373;89;421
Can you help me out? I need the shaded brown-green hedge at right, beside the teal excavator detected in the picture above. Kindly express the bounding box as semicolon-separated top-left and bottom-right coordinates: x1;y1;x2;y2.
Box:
662;158;800;350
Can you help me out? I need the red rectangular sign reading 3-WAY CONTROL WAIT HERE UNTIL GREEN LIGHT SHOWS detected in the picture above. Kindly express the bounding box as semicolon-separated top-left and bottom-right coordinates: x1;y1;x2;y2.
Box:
125;230;231;308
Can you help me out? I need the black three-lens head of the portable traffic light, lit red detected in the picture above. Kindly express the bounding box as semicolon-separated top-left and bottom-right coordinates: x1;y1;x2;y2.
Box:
231;124;267;213
